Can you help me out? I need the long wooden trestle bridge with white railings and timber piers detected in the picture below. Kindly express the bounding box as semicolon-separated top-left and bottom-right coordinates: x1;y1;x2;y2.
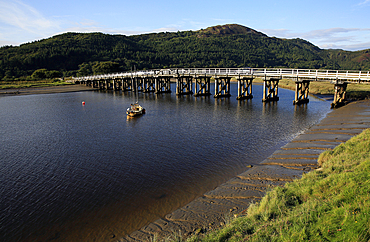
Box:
74;68;370;106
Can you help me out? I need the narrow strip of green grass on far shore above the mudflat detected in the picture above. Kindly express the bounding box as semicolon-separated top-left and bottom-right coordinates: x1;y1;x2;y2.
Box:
0;79;73;89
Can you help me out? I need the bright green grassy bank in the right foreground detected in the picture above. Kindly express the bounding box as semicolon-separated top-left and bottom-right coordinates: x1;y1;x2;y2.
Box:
187;129;370;242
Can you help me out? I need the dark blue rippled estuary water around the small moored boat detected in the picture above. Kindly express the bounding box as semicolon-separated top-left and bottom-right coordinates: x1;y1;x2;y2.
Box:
0;83;330;241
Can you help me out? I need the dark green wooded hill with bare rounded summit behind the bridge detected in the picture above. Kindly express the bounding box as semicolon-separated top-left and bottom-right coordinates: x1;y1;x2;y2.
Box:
0;24;370;80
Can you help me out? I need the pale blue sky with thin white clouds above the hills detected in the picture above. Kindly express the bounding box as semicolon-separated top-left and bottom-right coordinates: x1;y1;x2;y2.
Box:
0;0;370;51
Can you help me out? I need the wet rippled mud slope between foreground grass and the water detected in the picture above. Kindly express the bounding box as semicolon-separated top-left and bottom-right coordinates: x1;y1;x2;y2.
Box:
123;100;370;241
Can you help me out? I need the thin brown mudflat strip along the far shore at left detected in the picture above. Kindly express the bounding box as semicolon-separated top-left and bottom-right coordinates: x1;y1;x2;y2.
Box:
0;84;96;96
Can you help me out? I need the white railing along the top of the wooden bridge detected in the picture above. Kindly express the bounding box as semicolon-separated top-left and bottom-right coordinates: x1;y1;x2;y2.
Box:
74;68;370;82
